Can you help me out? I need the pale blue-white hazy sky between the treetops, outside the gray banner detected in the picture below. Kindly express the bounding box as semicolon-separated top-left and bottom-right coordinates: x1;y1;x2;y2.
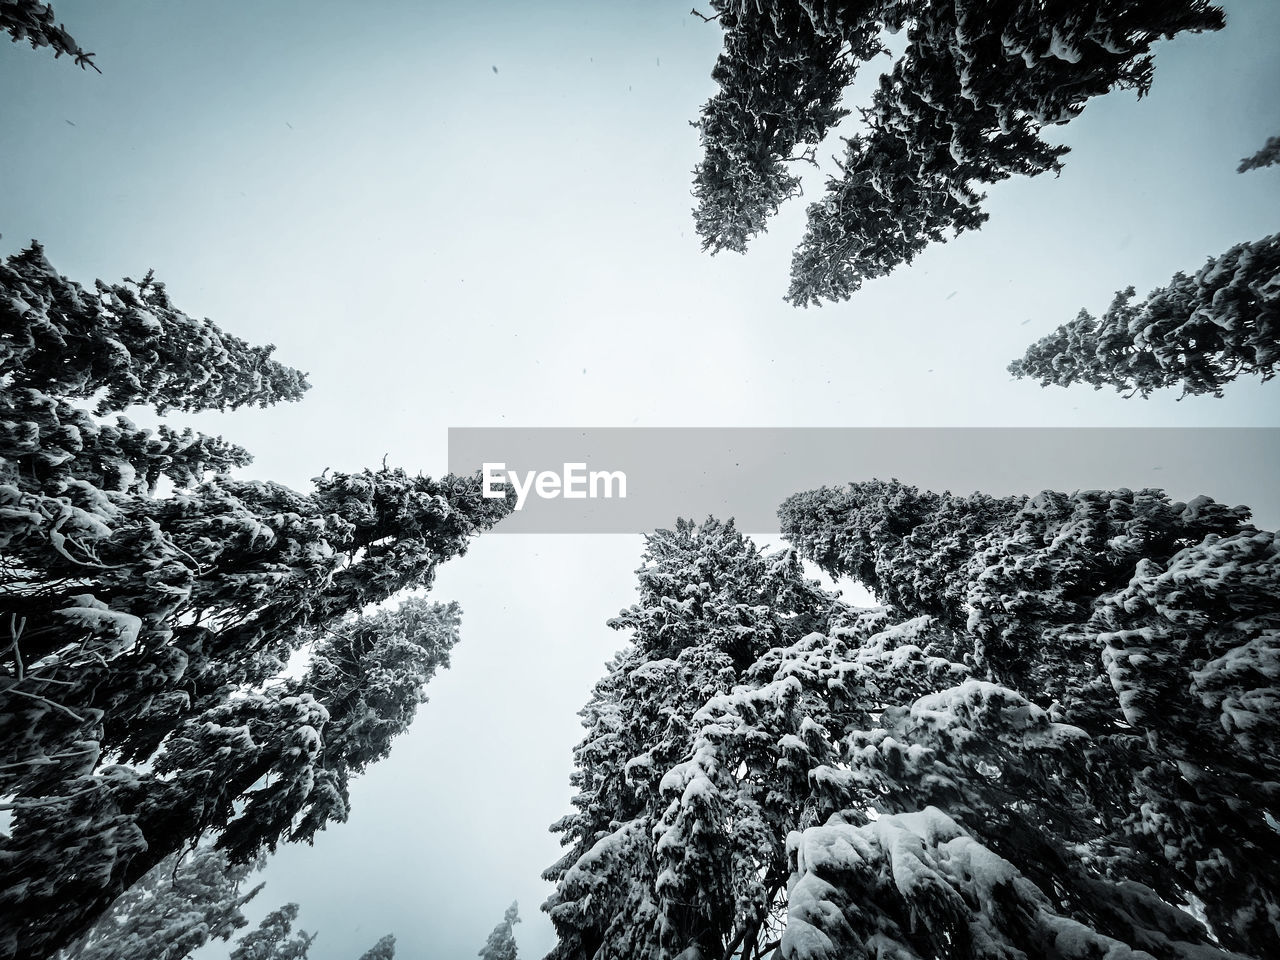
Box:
0;0;1280;960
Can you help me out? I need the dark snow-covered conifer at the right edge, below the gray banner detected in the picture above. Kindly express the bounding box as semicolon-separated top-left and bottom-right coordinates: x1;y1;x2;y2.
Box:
1092;529;1280;956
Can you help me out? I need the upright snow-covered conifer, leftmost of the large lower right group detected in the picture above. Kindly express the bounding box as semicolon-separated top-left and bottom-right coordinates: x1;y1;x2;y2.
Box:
543;521;835;960
